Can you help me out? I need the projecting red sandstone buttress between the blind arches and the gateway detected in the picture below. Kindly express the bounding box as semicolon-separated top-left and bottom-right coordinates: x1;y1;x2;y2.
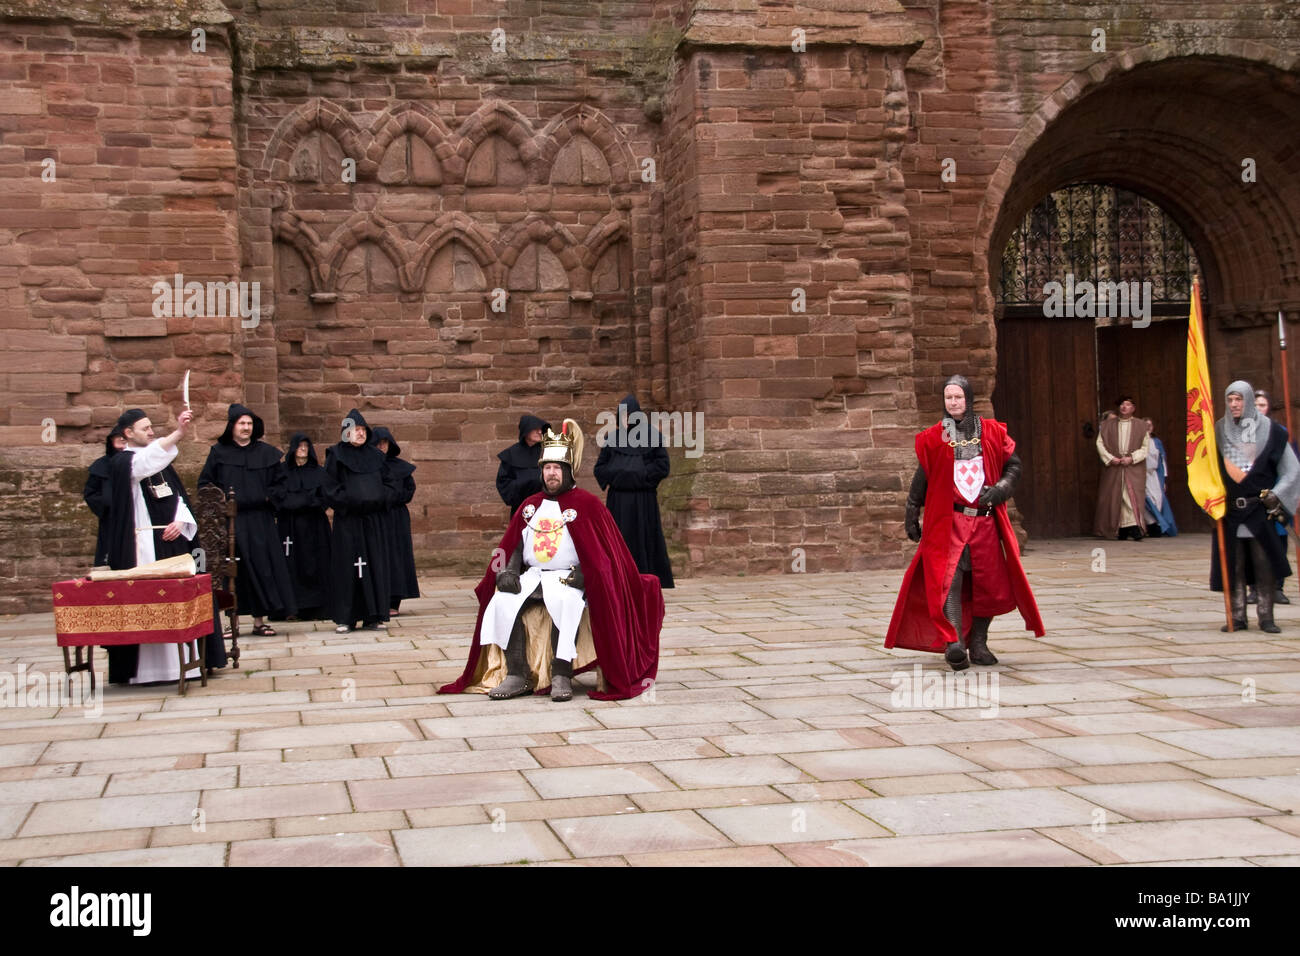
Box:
668;47;914;571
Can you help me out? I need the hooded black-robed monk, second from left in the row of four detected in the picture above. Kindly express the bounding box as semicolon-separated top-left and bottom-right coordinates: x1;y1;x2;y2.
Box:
272;432;333;620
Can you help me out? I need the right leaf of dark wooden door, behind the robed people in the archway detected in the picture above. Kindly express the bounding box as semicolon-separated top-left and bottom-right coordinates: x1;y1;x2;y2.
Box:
1097;319;1214;532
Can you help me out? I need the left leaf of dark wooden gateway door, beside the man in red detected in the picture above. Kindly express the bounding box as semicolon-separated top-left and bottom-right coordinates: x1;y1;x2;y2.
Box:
993;313;1101;537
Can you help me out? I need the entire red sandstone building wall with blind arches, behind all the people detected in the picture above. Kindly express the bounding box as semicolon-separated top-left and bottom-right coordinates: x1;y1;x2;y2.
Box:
0;0;1300;609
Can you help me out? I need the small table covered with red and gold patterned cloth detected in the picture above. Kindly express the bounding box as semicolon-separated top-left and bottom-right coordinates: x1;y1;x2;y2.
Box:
52;574;212;695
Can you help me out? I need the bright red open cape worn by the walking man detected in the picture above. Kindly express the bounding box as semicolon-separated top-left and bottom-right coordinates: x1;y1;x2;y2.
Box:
885;419;1044;653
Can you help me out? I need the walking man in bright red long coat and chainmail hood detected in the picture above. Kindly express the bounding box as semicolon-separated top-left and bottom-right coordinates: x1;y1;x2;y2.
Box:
885;375;1043;670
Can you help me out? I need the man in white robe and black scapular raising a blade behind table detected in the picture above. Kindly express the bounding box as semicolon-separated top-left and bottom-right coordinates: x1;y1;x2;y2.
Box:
108;408;226;684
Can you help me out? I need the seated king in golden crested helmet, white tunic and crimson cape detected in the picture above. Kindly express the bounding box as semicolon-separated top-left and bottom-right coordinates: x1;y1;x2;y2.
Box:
439;419;663;701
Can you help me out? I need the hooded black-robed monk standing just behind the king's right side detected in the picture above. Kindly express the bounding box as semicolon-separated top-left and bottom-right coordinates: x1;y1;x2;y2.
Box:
592;395;672;588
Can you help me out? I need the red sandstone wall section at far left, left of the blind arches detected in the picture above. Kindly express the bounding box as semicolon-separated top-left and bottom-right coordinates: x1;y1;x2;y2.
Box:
0;14;242;610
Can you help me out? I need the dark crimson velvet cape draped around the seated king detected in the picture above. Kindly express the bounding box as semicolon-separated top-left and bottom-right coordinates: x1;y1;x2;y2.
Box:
438;488;663;700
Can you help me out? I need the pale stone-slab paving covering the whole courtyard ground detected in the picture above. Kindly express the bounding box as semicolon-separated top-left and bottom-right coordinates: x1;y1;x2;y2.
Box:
0;535;1300;866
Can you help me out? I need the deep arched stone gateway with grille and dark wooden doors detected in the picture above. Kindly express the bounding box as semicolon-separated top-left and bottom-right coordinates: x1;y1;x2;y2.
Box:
985;49;1300;536
